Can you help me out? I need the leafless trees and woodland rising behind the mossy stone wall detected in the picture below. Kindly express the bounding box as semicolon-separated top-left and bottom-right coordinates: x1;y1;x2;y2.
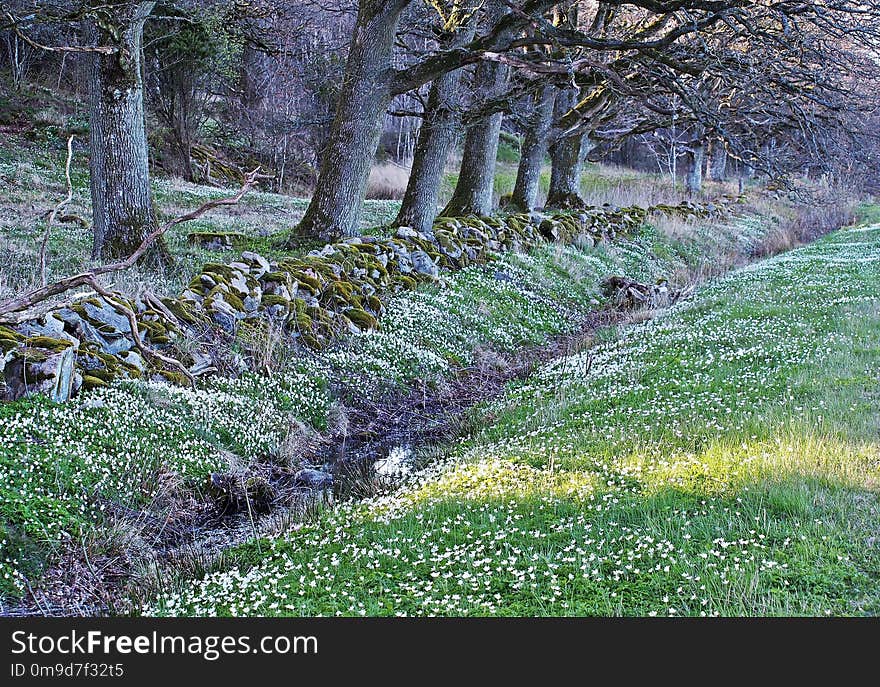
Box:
0;0;880;258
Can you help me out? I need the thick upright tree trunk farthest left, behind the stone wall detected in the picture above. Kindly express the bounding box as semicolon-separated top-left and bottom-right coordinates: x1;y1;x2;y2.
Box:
89;2;164;259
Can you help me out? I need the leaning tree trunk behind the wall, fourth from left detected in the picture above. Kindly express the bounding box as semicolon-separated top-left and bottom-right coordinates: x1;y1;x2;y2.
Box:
441;62;507;217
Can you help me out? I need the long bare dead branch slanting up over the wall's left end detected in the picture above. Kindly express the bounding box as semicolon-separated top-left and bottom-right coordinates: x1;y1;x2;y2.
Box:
0;167;262;324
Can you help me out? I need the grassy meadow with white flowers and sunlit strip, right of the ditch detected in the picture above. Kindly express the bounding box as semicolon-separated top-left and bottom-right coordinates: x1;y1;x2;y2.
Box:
151;226;880;615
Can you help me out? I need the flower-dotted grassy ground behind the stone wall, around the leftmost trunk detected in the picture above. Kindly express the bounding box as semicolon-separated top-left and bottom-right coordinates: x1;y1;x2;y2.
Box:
0;136;400;299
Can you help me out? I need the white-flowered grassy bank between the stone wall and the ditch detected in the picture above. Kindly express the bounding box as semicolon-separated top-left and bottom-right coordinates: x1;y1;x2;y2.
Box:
0;206;766;593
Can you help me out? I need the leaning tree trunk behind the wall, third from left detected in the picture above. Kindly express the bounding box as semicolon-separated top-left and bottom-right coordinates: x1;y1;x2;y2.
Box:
394;25;474;232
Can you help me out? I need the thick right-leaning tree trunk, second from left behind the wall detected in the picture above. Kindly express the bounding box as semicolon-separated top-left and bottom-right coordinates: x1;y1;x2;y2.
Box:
291;0;409;241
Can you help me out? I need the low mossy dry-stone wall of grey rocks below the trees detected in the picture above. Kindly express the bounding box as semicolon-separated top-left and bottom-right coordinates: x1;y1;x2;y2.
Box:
0;199;733;402
